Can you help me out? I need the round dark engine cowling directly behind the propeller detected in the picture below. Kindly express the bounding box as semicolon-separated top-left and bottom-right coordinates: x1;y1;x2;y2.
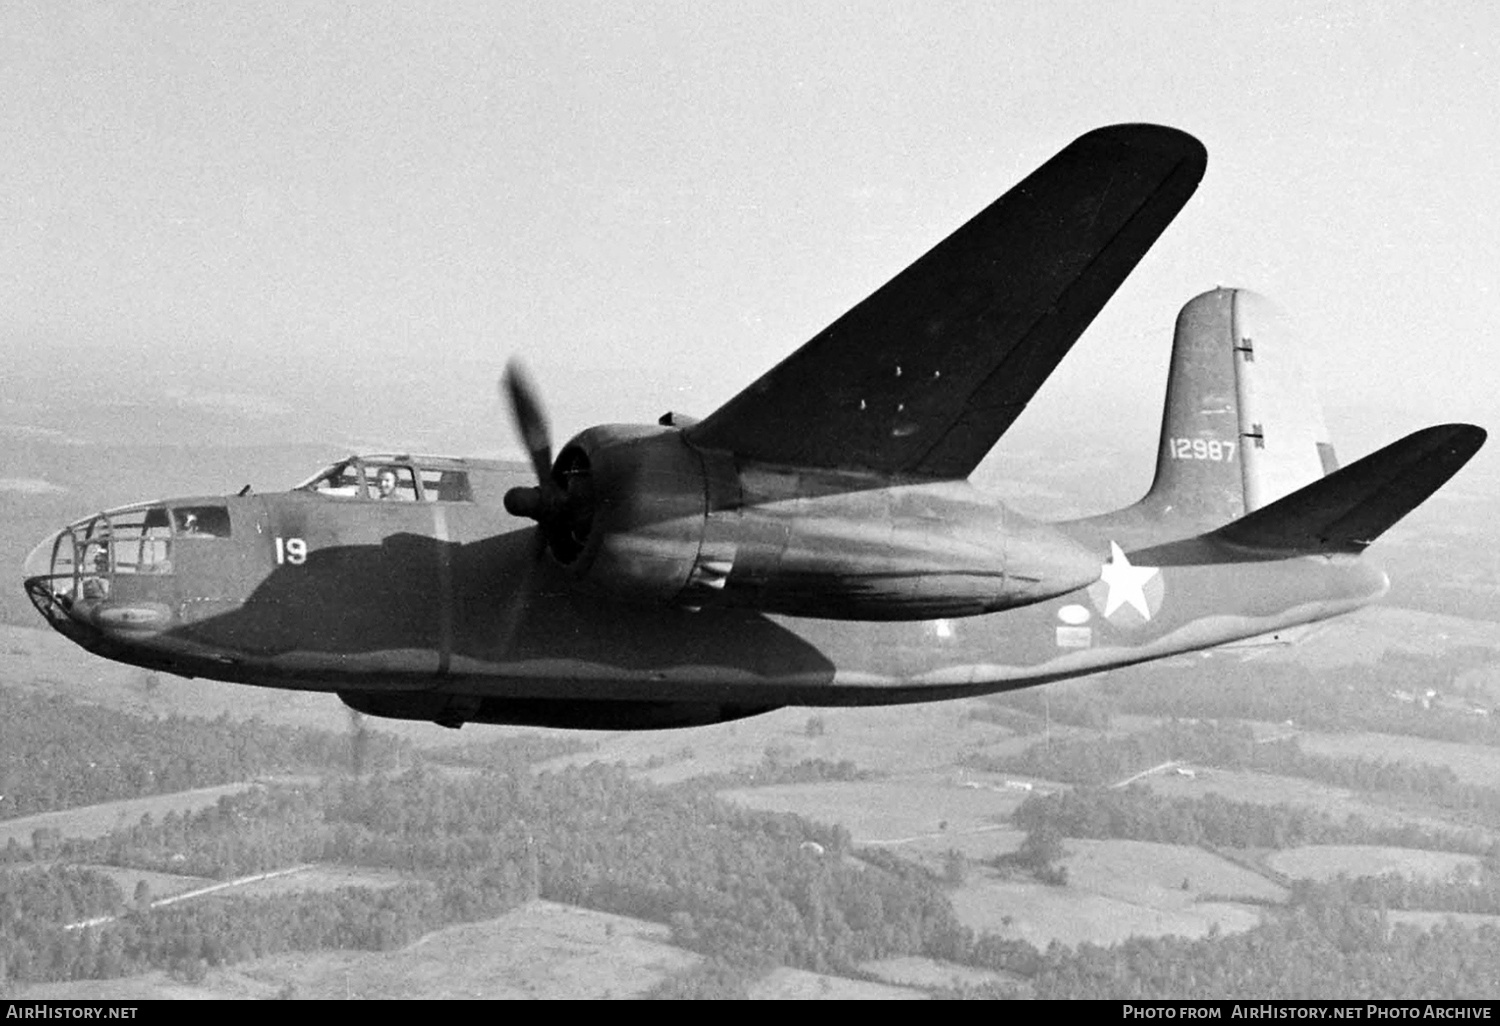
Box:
546;425;738;605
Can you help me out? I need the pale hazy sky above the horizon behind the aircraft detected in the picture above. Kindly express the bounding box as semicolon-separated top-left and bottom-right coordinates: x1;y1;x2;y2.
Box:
0;0;1500;455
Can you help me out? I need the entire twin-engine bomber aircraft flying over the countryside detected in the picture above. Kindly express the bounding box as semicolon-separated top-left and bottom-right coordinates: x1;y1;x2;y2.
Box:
26;125;1485;729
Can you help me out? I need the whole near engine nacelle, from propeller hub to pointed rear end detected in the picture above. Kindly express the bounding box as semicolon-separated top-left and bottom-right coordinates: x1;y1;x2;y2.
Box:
519;425;1101;620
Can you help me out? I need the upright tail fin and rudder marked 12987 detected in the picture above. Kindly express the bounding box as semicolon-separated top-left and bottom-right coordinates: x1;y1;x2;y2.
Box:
1140;288;1338;527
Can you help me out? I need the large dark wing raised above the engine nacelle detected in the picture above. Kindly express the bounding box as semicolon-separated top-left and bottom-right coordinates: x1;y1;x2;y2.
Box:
687;125;1208;479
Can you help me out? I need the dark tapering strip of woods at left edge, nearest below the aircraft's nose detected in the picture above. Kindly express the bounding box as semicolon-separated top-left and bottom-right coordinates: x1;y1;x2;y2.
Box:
0;689;410;819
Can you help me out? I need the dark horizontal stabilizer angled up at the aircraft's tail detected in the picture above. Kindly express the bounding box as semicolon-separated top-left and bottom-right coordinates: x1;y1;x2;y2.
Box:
1209;425;1485;554
